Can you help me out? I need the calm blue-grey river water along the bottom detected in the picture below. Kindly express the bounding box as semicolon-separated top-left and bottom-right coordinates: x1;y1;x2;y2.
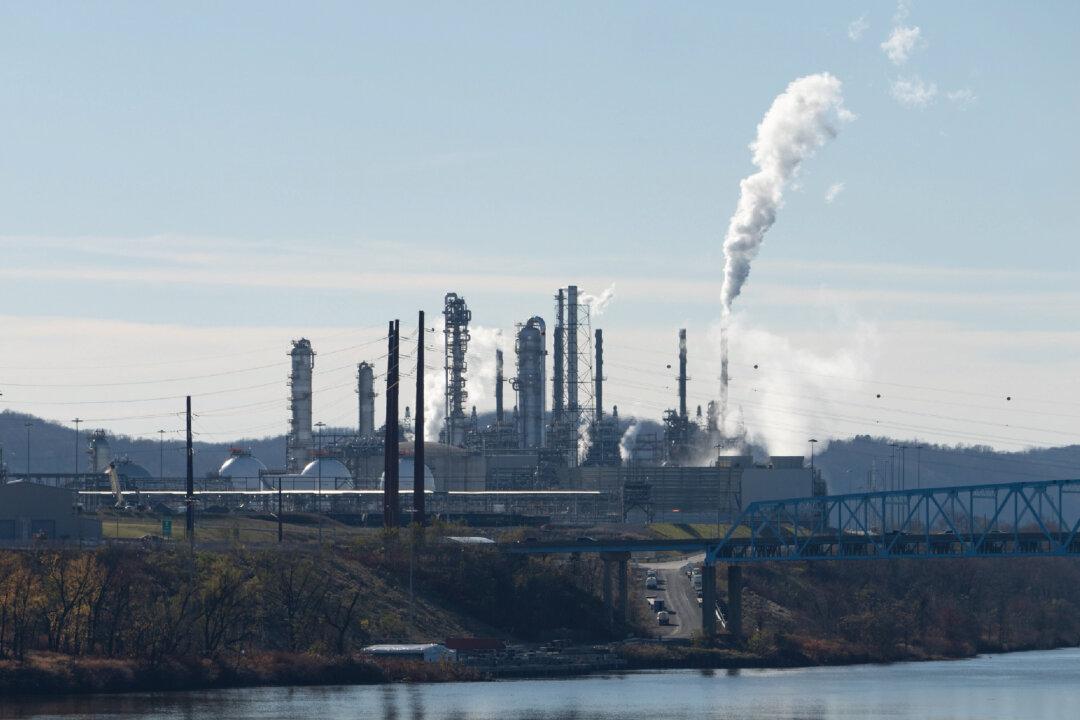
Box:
0;650;1080;720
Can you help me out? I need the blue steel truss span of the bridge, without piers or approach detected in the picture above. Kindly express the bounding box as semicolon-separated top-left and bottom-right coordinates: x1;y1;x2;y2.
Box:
707;479;1080;562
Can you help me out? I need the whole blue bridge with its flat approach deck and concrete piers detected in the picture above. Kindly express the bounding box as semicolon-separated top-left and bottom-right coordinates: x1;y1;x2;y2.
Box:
502;479;1080;640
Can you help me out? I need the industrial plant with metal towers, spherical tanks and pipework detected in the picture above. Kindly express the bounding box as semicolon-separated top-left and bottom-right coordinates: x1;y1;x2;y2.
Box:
25;285;824;525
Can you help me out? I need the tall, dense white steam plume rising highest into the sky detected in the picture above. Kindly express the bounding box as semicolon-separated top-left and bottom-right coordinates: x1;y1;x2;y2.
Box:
721;72;854;317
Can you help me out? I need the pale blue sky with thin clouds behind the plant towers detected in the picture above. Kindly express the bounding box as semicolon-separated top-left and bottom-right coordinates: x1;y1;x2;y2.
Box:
0;1;1080;454
